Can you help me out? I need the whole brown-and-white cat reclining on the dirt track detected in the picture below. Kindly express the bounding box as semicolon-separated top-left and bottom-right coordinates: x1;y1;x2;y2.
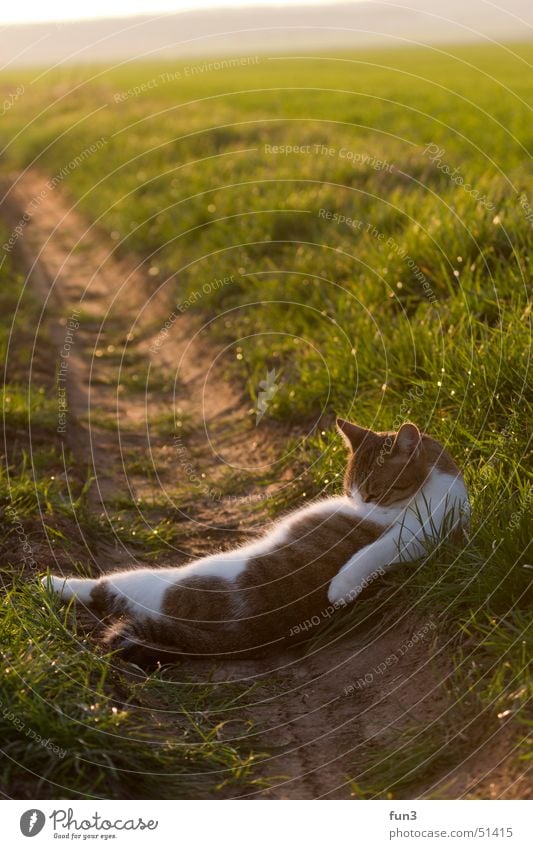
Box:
43;419;469;662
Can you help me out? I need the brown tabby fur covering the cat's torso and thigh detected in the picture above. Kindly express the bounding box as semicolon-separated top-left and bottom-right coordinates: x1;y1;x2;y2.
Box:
122;507;383;659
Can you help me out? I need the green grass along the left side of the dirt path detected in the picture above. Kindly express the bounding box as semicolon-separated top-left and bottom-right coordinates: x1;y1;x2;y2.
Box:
0;243;266;799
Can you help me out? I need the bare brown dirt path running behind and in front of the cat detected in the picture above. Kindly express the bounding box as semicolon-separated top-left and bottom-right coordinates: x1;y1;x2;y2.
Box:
3;171;462;799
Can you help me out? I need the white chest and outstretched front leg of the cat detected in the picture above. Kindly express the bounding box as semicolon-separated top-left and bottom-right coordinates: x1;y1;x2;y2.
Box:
328;468;469;604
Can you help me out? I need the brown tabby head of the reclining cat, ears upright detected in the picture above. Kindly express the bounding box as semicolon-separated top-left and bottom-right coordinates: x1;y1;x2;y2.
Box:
337;419;428;505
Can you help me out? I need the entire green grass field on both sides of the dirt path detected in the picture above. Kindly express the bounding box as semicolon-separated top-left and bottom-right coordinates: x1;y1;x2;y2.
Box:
0;45;533;798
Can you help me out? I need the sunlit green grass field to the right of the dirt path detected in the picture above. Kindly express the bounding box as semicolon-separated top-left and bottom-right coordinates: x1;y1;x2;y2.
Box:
0;39;533;797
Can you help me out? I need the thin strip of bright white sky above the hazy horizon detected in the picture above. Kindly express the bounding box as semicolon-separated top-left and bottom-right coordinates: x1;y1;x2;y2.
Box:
0;0;357;24
